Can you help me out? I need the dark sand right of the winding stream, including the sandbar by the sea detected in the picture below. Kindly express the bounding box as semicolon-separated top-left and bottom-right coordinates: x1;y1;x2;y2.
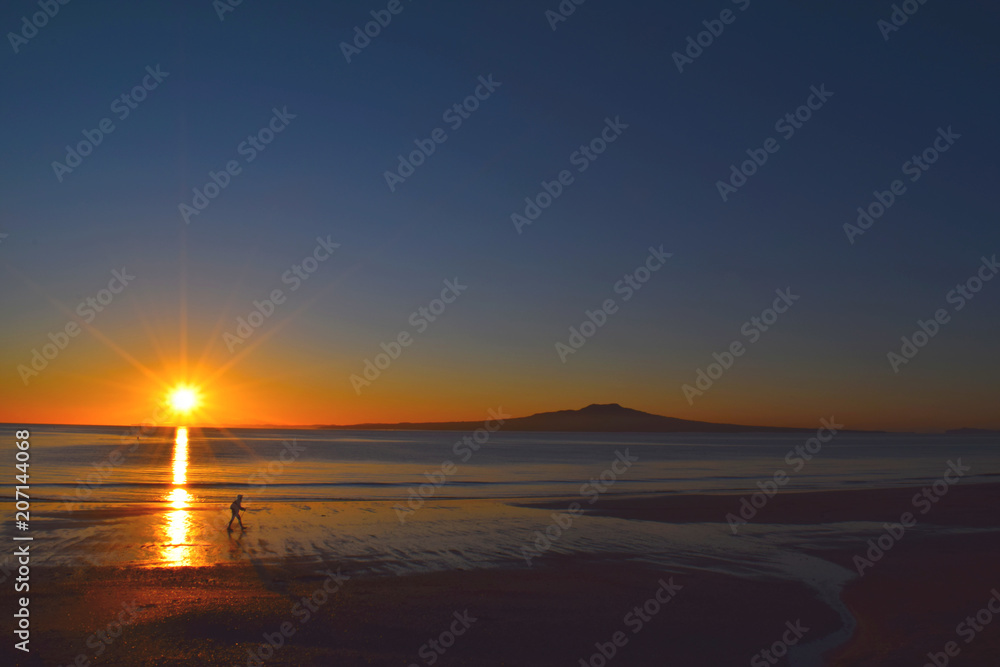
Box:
546;484;1000;667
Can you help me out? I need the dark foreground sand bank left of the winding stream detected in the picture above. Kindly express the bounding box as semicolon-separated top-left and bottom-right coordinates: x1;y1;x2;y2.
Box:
4;558;837;667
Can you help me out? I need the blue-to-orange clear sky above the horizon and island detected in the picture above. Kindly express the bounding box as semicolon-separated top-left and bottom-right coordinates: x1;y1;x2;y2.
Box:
0;0;1000;431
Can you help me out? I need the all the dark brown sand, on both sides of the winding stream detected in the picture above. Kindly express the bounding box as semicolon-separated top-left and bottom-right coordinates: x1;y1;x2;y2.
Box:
0;485;1000;667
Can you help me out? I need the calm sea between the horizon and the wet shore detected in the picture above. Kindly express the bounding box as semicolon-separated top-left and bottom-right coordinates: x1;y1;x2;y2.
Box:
0;426;1000;503
